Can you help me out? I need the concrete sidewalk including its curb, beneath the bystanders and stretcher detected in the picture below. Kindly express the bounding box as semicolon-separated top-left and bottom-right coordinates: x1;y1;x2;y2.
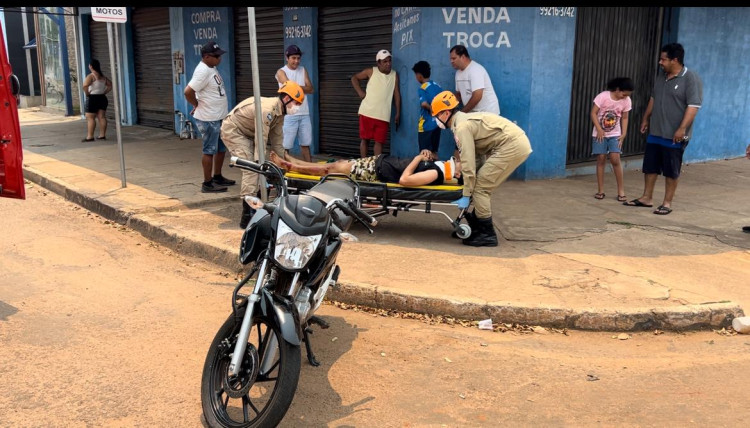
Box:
19;108;750;331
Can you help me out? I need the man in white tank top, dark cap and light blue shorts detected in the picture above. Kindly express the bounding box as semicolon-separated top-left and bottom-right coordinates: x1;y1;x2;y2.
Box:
276;45;315;162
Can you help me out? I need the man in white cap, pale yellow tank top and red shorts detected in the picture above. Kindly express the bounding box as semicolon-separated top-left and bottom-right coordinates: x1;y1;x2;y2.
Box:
351;49;401;158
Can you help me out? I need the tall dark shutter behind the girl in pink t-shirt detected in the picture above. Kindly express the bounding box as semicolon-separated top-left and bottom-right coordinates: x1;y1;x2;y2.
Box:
567;7;661;165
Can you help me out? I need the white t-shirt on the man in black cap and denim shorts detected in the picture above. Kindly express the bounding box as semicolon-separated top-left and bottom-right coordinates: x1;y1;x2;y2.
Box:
188;61;227;122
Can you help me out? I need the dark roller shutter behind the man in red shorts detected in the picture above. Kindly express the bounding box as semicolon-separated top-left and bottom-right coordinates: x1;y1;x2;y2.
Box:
317;7;394;157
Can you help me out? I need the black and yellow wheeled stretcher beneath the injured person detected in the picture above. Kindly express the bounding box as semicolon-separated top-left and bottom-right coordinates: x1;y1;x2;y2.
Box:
285;171;471;239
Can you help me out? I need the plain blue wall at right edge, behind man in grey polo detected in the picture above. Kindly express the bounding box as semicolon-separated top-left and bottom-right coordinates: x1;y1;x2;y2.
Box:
674;7;750;162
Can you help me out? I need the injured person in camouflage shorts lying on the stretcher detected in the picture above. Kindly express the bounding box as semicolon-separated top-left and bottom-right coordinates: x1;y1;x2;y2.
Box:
269;151;463;186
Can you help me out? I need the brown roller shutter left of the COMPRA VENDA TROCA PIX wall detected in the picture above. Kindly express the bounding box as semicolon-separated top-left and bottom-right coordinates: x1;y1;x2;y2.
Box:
133;7;174;129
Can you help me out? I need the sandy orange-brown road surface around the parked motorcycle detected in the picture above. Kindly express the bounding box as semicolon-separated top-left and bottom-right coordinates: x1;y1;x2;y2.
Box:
0;185;750;427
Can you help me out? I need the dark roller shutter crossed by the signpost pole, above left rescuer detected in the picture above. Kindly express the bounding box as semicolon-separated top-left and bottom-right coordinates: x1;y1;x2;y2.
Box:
234;7;284;103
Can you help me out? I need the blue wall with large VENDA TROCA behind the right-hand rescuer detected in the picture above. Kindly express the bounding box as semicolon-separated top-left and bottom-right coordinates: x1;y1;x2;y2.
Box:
391;7;575;179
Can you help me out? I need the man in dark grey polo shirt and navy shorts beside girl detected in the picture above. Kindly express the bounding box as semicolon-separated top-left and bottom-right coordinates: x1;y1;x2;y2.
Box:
623;43;703;215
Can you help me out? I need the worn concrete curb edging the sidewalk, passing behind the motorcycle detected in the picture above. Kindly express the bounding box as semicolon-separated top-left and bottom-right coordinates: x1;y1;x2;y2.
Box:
24;167;744;332
